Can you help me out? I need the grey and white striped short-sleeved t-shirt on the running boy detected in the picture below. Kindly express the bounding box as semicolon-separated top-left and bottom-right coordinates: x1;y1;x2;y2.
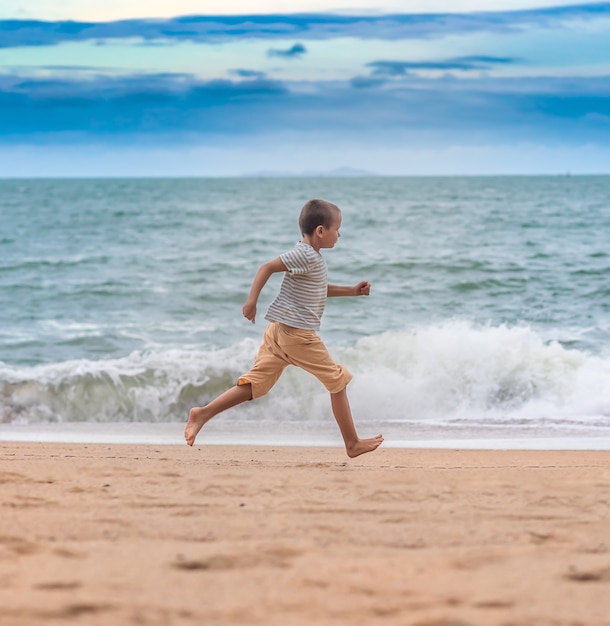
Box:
265;241;328;330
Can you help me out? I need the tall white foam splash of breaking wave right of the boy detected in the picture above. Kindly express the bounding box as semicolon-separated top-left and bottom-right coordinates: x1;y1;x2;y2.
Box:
346;322;610;426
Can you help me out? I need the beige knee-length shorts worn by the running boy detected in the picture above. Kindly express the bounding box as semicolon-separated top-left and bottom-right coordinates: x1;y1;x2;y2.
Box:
237;322;352;399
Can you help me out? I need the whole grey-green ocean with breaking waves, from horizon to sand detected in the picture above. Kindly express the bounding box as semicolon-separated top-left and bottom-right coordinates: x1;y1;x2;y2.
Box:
0;176;610;448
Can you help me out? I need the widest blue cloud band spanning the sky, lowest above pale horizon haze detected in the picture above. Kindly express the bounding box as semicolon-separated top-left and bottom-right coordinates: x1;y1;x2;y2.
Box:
0;74;610;144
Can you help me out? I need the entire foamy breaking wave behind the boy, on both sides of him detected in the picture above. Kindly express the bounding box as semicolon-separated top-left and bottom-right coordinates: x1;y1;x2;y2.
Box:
0;321;610;428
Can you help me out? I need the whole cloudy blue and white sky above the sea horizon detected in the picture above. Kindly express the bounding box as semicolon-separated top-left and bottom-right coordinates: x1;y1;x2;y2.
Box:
0;0;610;178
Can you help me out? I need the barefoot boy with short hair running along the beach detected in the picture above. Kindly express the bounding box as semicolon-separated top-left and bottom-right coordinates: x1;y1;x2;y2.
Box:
184;200;383;458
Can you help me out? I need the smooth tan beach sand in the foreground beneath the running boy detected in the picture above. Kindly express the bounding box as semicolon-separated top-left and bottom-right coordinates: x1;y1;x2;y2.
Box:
0;442;610;626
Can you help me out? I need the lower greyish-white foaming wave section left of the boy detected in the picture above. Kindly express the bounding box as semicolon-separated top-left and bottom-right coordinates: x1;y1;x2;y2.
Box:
0;340;257;423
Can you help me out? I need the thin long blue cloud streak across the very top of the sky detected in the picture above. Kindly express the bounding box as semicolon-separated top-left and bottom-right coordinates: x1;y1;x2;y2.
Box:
0;2;610;48
